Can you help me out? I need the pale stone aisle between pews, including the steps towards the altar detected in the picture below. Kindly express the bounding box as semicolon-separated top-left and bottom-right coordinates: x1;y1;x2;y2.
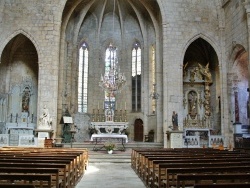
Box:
76;149;145;188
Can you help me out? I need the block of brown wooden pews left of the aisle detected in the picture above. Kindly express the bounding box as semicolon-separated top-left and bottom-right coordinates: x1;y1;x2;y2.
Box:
0;147;88;188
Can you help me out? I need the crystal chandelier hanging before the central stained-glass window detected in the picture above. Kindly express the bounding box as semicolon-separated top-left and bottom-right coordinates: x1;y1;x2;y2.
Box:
99;44;126;96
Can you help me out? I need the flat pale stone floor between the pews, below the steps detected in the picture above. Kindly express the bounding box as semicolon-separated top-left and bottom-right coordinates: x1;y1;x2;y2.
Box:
76;163;145;188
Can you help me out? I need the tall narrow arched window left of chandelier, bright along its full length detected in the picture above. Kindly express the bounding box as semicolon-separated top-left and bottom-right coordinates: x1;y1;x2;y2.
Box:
78;42;89;113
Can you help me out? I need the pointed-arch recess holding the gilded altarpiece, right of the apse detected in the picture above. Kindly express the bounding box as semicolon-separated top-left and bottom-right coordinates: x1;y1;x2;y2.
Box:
183;37;221;143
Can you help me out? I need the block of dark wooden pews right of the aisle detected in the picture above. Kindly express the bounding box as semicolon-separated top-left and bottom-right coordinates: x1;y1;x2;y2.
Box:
131;148;250;188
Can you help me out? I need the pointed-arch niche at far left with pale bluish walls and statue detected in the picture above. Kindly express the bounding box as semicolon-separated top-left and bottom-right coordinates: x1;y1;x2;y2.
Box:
0;34;38;126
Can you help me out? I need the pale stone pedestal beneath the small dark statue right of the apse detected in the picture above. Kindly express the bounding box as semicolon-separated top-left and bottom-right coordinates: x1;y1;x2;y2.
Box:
166;131;183;148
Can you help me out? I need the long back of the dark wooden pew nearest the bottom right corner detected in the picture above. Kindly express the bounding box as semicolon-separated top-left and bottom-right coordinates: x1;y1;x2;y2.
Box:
176;173;250;188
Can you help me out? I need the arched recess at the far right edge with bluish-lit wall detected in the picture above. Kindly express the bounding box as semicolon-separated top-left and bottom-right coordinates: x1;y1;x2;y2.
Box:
228;44;250;124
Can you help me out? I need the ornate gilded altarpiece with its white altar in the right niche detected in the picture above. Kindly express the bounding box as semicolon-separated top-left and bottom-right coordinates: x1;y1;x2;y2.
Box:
183;62;223;147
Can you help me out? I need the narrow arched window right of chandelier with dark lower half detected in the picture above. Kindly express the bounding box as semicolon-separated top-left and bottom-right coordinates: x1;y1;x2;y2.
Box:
132;42;141;111
